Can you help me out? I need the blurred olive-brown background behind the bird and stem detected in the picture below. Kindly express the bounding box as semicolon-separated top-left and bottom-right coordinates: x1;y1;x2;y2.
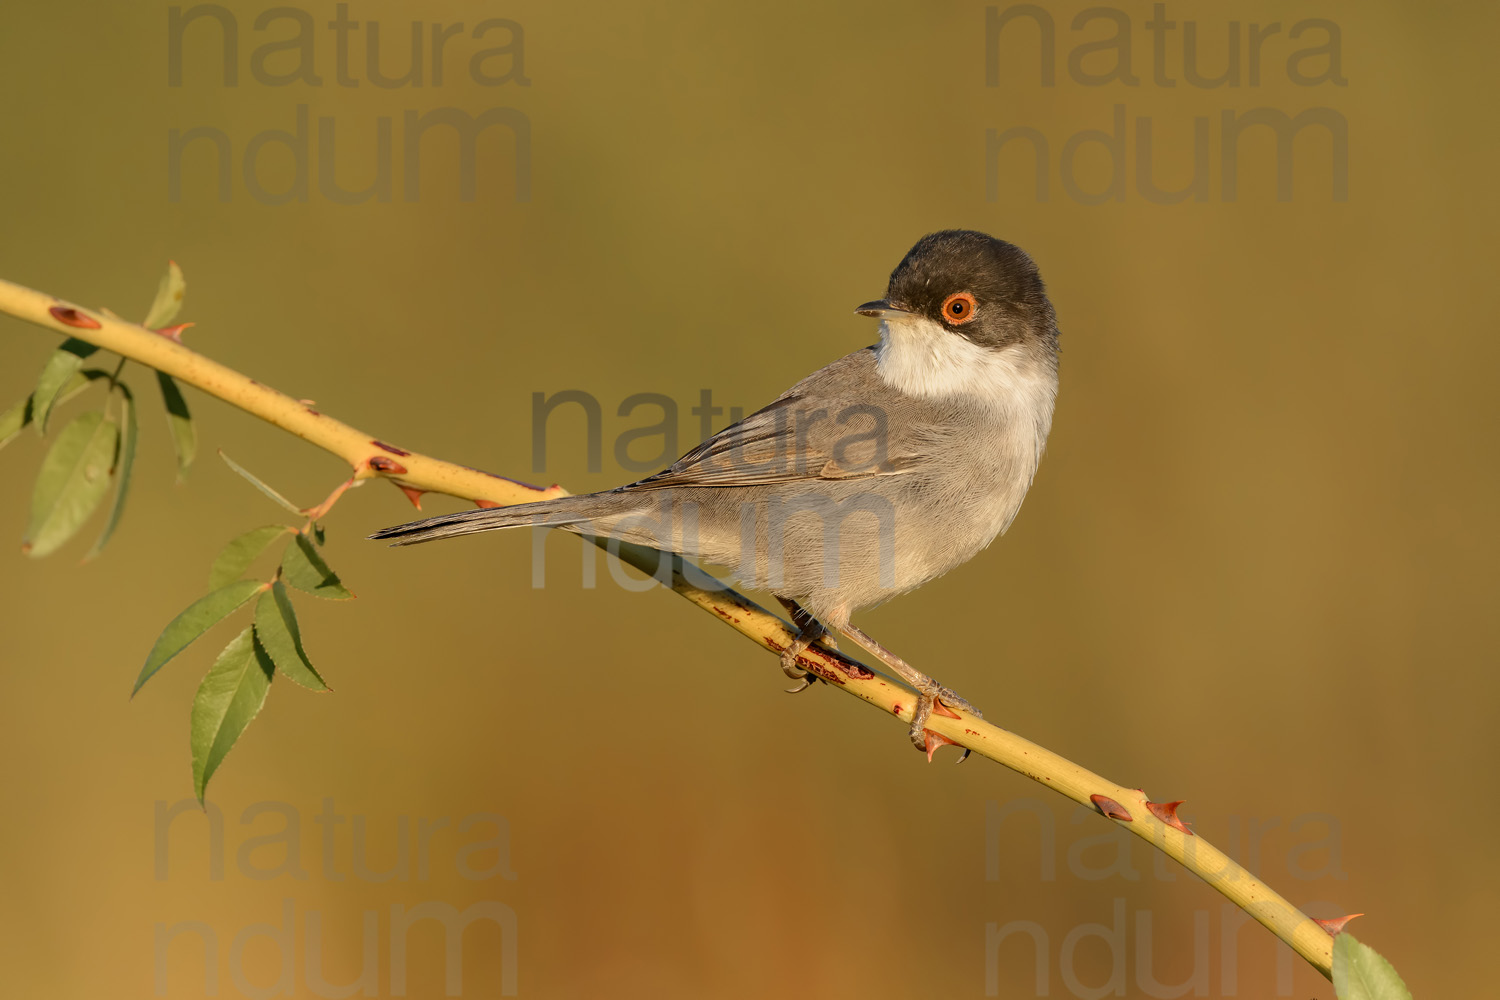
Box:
0;0;1500;997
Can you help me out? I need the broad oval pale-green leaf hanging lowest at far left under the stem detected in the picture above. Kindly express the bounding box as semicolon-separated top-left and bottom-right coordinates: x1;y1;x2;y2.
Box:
21;409;120;559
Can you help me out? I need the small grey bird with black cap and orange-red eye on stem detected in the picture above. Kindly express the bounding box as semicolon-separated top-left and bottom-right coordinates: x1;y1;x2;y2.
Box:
371;229;1058;748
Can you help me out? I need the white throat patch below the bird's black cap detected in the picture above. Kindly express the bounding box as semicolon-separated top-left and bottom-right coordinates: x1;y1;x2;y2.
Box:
875;316;1058;462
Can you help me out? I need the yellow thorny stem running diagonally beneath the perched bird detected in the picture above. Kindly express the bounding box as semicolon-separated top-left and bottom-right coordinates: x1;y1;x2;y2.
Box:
0;280;1334;978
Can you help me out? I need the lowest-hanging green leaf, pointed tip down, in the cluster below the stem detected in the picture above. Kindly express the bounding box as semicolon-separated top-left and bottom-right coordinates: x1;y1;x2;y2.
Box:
191;627;275;802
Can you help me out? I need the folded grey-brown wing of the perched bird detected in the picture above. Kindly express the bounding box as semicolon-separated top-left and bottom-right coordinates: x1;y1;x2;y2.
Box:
620;348;923;490
